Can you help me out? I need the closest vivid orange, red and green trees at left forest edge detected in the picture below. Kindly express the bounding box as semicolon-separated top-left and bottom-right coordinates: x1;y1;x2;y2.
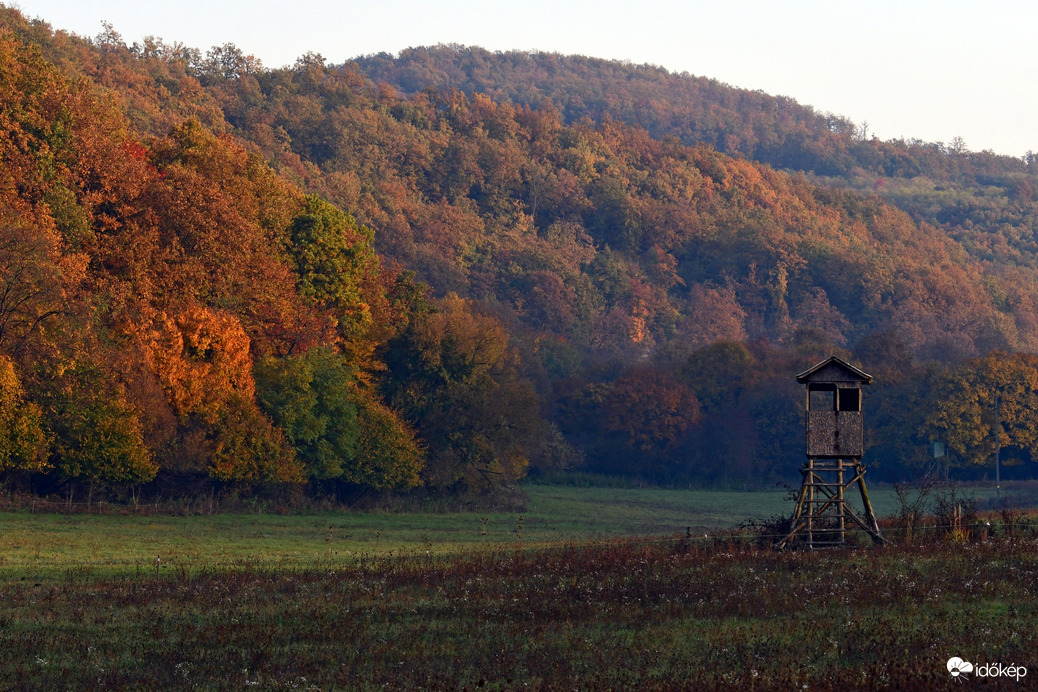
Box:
0;12;540;500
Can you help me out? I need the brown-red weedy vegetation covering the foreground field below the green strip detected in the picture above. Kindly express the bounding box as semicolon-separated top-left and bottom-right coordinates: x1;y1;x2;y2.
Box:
0;526;1038;690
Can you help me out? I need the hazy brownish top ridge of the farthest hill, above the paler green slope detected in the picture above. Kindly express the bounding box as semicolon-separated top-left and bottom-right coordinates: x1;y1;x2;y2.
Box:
352;45;1035;185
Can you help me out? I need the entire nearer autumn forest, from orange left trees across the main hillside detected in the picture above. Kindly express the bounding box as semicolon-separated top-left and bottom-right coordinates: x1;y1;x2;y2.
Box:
0;9;1038;504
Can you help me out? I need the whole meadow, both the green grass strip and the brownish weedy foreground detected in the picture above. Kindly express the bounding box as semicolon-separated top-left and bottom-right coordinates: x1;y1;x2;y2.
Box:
0;486;1038;690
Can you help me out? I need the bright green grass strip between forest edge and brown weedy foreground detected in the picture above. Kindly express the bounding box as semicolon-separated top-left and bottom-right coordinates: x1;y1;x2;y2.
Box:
0;485;1004;580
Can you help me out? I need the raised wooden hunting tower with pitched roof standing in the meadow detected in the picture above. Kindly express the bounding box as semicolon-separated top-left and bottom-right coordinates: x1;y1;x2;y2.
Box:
775;356;883;549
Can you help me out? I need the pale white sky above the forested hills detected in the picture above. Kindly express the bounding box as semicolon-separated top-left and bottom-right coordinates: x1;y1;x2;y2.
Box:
6;0;1038;156
